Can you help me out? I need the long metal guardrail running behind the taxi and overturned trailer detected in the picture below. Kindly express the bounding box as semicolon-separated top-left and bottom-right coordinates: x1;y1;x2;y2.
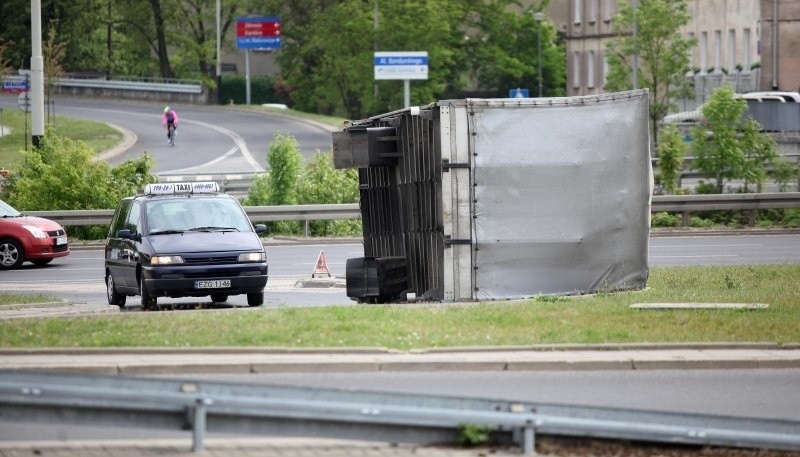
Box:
25;192;800;226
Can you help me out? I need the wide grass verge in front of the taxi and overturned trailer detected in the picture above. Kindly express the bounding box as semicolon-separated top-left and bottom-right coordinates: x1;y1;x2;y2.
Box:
0;264;800;350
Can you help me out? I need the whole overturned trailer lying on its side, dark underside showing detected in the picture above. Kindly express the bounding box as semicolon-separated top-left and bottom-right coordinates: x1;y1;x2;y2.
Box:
333;90;653;303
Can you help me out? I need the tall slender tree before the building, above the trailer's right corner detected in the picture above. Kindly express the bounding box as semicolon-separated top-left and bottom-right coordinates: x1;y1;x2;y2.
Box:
605;0;697;144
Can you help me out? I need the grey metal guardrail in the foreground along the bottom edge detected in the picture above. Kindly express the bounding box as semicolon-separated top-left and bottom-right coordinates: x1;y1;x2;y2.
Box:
0;371;800;455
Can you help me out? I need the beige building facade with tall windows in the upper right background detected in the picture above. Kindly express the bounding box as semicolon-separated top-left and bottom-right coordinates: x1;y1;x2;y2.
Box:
554;0;800;103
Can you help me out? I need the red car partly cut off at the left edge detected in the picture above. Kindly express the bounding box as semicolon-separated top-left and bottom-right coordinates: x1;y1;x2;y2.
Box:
0;200;69;270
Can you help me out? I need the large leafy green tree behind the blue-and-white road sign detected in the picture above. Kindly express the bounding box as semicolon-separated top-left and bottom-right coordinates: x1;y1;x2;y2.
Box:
264;0;482;118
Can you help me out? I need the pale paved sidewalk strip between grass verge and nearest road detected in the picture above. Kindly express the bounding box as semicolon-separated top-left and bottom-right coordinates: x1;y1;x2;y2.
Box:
0;343;800;375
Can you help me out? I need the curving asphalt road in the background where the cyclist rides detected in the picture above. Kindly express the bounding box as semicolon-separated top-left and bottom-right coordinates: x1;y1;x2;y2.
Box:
0;95;333;174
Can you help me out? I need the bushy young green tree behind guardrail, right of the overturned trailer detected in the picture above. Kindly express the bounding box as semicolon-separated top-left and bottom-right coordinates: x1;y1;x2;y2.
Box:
692;84;777;193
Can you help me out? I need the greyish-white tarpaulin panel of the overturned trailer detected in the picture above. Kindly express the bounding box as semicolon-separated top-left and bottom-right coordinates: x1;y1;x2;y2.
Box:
466;90;653;300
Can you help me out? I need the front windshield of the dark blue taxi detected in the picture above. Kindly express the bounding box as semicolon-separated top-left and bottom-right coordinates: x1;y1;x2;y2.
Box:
145;198;253;235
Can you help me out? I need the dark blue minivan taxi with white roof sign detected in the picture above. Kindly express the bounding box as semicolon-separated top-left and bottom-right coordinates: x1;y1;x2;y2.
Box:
105;182;268;310
